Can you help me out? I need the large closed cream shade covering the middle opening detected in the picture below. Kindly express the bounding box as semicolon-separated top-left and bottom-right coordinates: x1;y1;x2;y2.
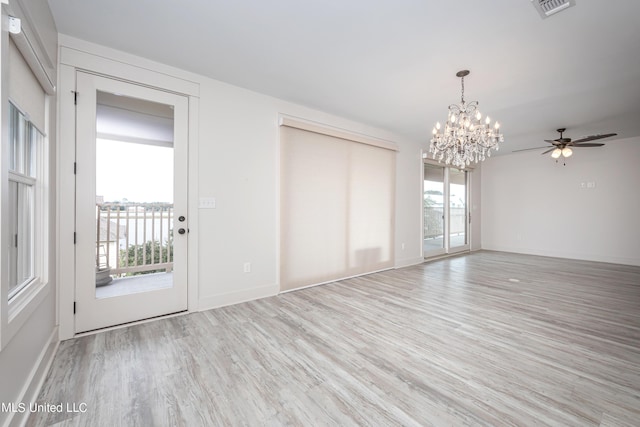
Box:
280;125;396;291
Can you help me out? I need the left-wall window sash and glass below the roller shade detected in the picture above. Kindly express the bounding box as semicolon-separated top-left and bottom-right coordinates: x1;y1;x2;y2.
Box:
7;103;44;300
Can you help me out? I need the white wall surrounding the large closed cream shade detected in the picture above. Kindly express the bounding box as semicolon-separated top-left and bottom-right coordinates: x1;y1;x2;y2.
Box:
198;77;422;308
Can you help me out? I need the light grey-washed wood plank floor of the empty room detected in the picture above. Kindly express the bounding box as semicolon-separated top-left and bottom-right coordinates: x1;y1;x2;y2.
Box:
29;252;640;426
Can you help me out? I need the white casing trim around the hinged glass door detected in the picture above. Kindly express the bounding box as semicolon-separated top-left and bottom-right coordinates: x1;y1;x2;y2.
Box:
55;45;200;340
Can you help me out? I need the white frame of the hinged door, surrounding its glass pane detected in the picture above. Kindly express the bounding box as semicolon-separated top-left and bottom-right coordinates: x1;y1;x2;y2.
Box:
75;71;190;333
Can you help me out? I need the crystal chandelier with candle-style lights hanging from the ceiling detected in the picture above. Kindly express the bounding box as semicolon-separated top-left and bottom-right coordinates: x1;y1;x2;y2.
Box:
429;70;504;169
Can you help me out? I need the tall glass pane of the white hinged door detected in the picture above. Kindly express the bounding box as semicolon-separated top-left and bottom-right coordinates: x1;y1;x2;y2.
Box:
96;91;174;298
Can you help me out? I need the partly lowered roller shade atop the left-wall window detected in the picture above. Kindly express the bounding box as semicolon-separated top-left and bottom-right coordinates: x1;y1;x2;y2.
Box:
9;38;47;133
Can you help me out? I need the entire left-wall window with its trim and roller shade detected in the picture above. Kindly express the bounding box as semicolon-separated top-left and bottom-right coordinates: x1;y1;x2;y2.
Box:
0;6;56;350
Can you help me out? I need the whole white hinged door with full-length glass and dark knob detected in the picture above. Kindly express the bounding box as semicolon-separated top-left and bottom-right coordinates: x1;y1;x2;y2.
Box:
75;72;188;333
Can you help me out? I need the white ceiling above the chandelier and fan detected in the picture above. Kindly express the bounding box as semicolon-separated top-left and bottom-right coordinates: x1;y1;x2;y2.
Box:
49;0;640;153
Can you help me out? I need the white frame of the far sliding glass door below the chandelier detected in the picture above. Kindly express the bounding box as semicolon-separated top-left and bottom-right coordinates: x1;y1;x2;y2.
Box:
420;157;473;259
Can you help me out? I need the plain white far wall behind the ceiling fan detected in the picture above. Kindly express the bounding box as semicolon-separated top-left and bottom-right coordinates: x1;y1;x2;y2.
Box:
482;138;640;265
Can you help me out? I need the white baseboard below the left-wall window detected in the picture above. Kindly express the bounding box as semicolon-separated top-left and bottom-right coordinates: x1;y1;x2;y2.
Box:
5;326;60;427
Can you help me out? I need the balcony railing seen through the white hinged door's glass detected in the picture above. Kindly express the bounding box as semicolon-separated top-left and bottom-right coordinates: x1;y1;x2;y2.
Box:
96;203;173;277
